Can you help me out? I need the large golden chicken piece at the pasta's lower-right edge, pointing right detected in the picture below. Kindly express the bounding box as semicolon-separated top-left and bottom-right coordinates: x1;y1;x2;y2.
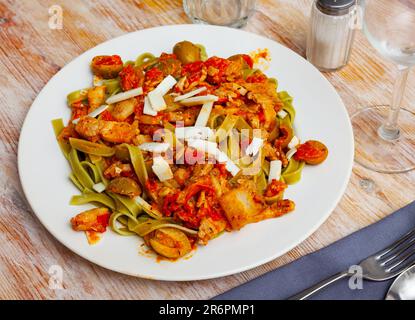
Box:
219;180;295;230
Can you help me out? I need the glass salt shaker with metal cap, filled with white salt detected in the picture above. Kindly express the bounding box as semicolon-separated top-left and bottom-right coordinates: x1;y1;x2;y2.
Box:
306;0;357;72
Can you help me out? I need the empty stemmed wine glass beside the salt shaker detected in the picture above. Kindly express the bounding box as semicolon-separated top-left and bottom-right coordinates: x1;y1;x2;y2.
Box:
351;0;415;173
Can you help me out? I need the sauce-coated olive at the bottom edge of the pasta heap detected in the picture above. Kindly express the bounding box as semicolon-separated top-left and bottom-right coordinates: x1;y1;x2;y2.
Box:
147;228;192;259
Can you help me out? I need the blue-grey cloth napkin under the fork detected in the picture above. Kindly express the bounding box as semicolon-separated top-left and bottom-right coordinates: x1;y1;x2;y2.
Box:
213;202;415;300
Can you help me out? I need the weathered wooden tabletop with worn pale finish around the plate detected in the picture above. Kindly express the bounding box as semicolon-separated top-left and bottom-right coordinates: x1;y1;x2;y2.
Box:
0;0;415;299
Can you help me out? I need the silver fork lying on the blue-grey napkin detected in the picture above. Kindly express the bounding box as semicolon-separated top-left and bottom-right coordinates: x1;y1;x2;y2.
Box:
289;229;415;300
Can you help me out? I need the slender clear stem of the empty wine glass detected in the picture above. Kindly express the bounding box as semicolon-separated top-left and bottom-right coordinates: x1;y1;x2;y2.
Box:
378;66;410;141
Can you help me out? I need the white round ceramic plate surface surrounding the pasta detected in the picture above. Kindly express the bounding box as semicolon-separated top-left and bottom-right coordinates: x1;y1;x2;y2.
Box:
18;25;353;280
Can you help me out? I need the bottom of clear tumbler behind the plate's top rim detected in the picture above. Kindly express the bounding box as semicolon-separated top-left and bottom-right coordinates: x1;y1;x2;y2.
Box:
183;0;255;28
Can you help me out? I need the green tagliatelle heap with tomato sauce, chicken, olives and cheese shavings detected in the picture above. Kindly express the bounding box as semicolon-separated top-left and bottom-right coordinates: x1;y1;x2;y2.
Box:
52;41;328;259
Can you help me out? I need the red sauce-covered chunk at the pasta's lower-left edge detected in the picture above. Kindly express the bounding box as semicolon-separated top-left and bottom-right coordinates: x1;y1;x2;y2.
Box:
71;208;110;232
